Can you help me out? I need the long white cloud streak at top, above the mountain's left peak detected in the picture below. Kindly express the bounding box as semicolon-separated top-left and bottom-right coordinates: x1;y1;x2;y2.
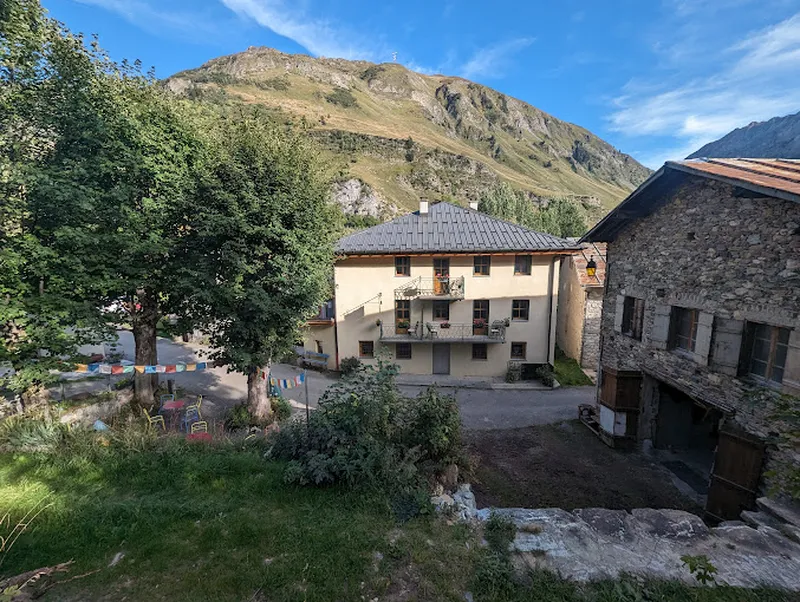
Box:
221;0;378;60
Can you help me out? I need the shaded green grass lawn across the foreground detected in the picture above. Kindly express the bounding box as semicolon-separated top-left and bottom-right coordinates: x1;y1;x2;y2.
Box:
0;439;792;602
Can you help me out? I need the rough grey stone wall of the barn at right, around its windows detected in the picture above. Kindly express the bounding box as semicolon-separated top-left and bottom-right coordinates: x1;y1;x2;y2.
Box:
601;177;800;440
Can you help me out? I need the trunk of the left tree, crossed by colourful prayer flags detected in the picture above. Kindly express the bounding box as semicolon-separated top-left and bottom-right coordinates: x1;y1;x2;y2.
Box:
131;291;158;407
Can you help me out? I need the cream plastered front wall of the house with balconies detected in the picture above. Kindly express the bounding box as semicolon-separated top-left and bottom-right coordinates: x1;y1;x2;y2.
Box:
335;255;559;376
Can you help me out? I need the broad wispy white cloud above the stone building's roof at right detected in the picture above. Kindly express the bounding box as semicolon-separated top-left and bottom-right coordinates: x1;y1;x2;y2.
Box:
609;13;800;167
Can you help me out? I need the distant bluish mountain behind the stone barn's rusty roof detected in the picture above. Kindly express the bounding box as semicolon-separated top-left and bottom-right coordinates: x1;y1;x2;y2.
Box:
686;113;800;159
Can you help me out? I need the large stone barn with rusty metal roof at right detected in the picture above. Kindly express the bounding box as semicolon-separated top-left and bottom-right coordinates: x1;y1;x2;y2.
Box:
582;159;800;519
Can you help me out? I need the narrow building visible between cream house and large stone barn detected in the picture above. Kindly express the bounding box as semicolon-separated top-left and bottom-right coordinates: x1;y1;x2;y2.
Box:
556;242;606;370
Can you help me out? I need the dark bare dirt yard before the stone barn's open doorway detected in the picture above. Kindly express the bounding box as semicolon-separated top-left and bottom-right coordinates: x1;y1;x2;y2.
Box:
465;420;701;513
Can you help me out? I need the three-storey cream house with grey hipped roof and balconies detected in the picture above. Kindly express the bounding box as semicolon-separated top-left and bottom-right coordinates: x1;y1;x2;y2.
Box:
305;201;576;376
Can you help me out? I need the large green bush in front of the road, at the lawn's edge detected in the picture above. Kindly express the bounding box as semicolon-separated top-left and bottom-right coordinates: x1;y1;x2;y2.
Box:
272;361;461;490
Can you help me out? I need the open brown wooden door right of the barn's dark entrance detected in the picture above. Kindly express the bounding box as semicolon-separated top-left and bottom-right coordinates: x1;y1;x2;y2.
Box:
706;424;765;520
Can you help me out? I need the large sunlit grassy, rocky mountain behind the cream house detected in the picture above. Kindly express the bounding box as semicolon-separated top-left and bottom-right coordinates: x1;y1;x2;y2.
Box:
166;47;649;217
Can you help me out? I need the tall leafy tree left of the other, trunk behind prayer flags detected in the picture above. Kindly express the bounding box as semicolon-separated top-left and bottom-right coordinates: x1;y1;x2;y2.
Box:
2;0;212;403
